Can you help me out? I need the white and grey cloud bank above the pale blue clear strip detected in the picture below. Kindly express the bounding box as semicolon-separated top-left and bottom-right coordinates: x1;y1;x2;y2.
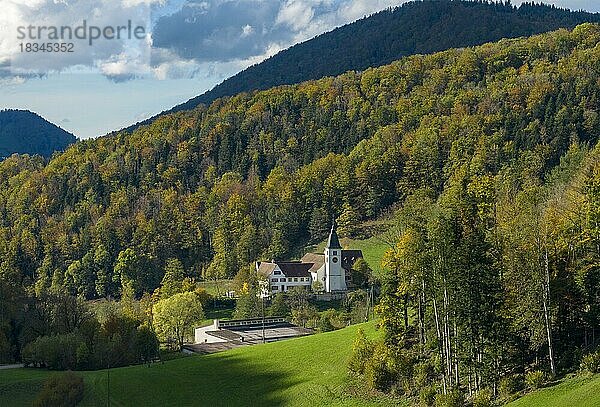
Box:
0;0;403;83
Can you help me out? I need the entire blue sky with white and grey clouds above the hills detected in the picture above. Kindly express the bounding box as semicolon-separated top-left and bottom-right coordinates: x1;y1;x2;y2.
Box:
0;0;600;138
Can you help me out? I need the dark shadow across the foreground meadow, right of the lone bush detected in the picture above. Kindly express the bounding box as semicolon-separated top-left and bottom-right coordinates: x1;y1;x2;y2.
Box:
84;353;298;406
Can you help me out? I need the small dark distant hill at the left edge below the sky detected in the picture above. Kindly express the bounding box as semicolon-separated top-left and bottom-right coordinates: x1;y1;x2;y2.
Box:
0;110;77;159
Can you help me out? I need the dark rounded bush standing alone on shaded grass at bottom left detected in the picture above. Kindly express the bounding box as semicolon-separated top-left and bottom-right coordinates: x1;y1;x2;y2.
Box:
33;372;84;407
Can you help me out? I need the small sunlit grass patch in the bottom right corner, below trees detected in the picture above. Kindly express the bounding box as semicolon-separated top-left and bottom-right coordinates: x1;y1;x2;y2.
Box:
508;375;600;407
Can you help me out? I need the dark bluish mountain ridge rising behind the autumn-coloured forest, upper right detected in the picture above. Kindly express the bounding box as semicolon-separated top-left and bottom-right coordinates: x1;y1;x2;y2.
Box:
126;0;600;131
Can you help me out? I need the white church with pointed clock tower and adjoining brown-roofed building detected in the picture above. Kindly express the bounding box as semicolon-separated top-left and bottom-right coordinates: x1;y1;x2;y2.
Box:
256;225;363;295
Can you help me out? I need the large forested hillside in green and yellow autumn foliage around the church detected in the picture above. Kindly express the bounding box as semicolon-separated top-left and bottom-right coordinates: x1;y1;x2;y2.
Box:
0;24;600;404
